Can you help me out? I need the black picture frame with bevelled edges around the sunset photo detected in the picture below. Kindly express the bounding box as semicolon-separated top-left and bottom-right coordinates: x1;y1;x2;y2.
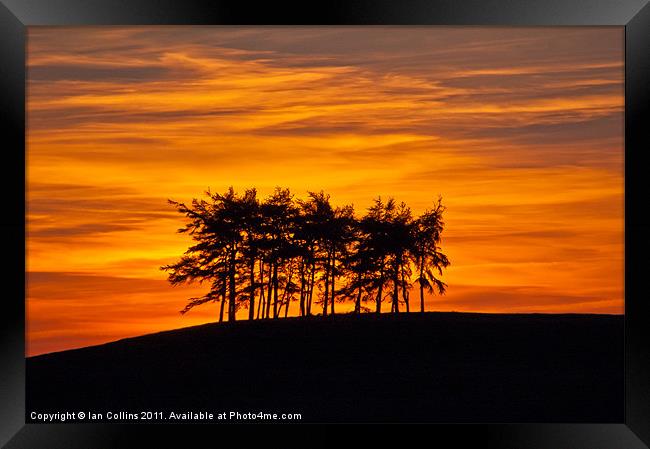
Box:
0;0;650;449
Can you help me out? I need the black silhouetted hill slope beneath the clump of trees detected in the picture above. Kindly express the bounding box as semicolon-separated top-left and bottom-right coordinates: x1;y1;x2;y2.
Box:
26;312;623;422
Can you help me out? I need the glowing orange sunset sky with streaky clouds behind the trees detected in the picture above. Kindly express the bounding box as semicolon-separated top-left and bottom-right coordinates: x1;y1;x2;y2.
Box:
27;27;624;355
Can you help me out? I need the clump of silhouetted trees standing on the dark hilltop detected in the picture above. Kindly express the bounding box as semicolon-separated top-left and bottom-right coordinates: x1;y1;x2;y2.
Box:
162;187;450;321
